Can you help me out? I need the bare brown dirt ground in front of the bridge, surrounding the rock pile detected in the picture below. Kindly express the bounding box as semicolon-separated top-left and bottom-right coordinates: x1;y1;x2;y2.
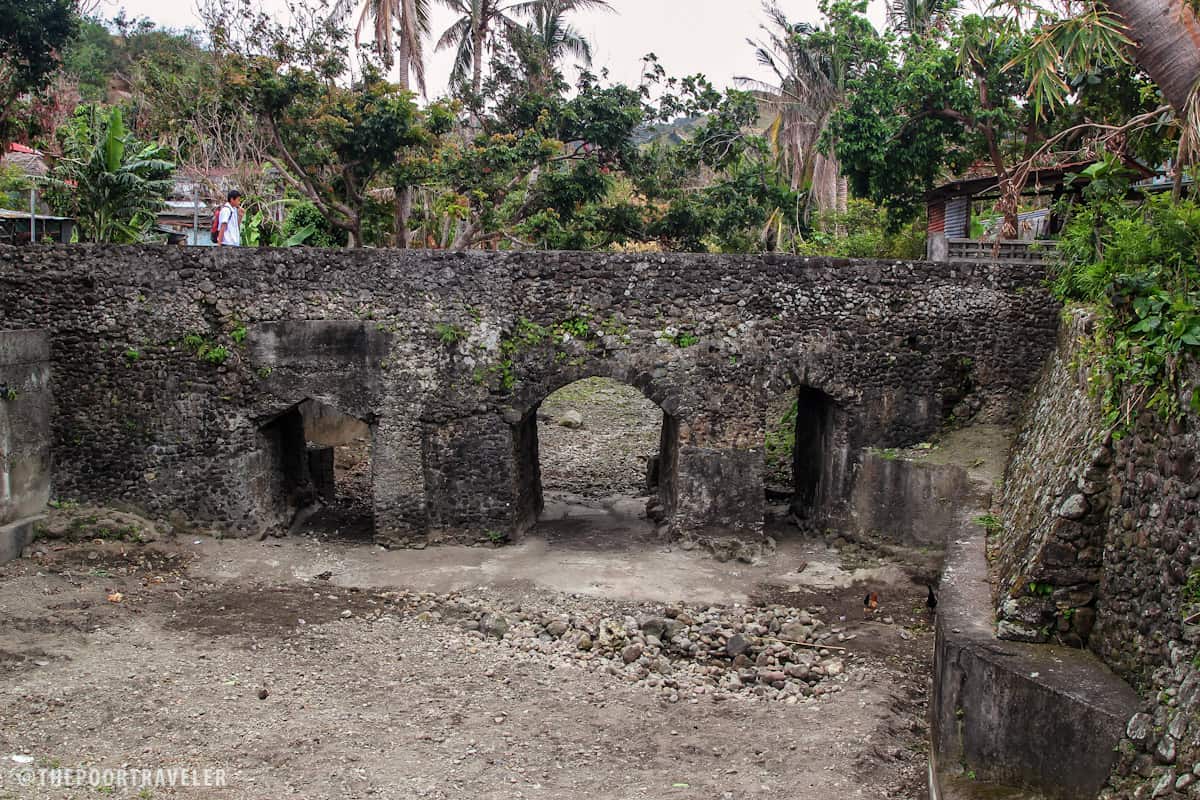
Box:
0;512;932;800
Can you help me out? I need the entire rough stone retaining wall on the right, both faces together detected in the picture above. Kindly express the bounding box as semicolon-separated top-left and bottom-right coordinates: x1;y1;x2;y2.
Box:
995;303;1200;798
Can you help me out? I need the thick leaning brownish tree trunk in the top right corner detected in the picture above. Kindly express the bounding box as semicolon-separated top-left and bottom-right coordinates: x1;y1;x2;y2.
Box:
1108;0;1200;113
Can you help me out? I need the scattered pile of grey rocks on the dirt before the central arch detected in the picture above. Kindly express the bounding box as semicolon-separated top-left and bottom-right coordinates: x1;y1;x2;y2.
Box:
388;594;852;703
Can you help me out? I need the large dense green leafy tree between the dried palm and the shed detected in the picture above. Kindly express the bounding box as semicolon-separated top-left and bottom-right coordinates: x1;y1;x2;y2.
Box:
830;8;1104;236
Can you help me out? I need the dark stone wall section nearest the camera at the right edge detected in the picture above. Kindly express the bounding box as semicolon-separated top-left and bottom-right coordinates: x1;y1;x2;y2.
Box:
1090;362;1200;798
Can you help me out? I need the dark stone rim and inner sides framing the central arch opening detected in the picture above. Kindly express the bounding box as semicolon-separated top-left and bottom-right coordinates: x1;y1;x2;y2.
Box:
512;361;682;535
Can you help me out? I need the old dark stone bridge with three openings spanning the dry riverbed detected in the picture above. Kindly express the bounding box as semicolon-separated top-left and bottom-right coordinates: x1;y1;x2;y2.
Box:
0;246;1058;551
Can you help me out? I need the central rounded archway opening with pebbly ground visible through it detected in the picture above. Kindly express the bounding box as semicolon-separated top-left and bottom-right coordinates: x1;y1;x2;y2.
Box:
514;375;679;533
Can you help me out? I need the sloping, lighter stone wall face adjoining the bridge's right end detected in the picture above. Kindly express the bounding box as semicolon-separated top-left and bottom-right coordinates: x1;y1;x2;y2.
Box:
997;311;1112;646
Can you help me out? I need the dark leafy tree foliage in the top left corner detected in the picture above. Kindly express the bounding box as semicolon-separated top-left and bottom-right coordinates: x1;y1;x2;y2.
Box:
0;0;79;146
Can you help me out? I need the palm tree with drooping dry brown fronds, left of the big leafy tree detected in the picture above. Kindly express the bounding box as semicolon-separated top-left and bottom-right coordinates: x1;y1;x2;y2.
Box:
737;2;844;210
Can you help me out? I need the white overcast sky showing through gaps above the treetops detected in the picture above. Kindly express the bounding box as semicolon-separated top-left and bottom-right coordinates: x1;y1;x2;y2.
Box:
100;0;883;96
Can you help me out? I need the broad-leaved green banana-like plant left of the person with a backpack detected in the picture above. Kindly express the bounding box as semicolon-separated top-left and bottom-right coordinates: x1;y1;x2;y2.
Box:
44;106;174;242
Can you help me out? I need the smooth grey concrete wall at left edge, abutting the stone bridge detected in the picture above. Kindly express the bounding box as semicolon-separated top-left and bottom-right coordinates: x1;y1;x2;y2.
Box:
0;331;50;563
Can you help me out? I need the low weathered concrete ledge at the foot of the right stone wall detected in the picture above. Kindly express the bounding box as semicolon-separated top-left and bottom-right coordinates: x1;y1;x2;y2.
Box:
930;507;1138;800
